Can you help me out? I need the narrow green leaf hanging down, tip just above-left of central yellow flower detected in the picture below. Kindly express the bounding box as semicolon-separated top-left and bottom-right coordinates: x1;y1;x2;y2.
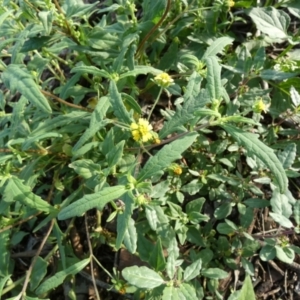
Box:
109;81;132;124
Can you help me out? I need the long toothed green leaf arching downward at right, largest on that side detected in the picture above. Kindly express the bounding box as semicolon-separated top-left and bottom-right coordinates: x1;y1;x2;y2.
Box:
220;124;288;193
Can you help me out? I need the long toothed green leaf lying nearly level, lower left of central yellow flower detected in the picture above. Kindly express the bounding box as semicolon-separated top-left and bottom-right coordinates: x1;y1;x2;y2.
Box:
58;185;126;220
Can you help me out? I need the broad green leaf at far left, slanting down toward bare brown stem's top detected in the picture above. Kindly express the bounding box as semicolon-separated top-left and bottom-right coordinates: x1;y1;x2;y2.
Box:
9;176;57;214
